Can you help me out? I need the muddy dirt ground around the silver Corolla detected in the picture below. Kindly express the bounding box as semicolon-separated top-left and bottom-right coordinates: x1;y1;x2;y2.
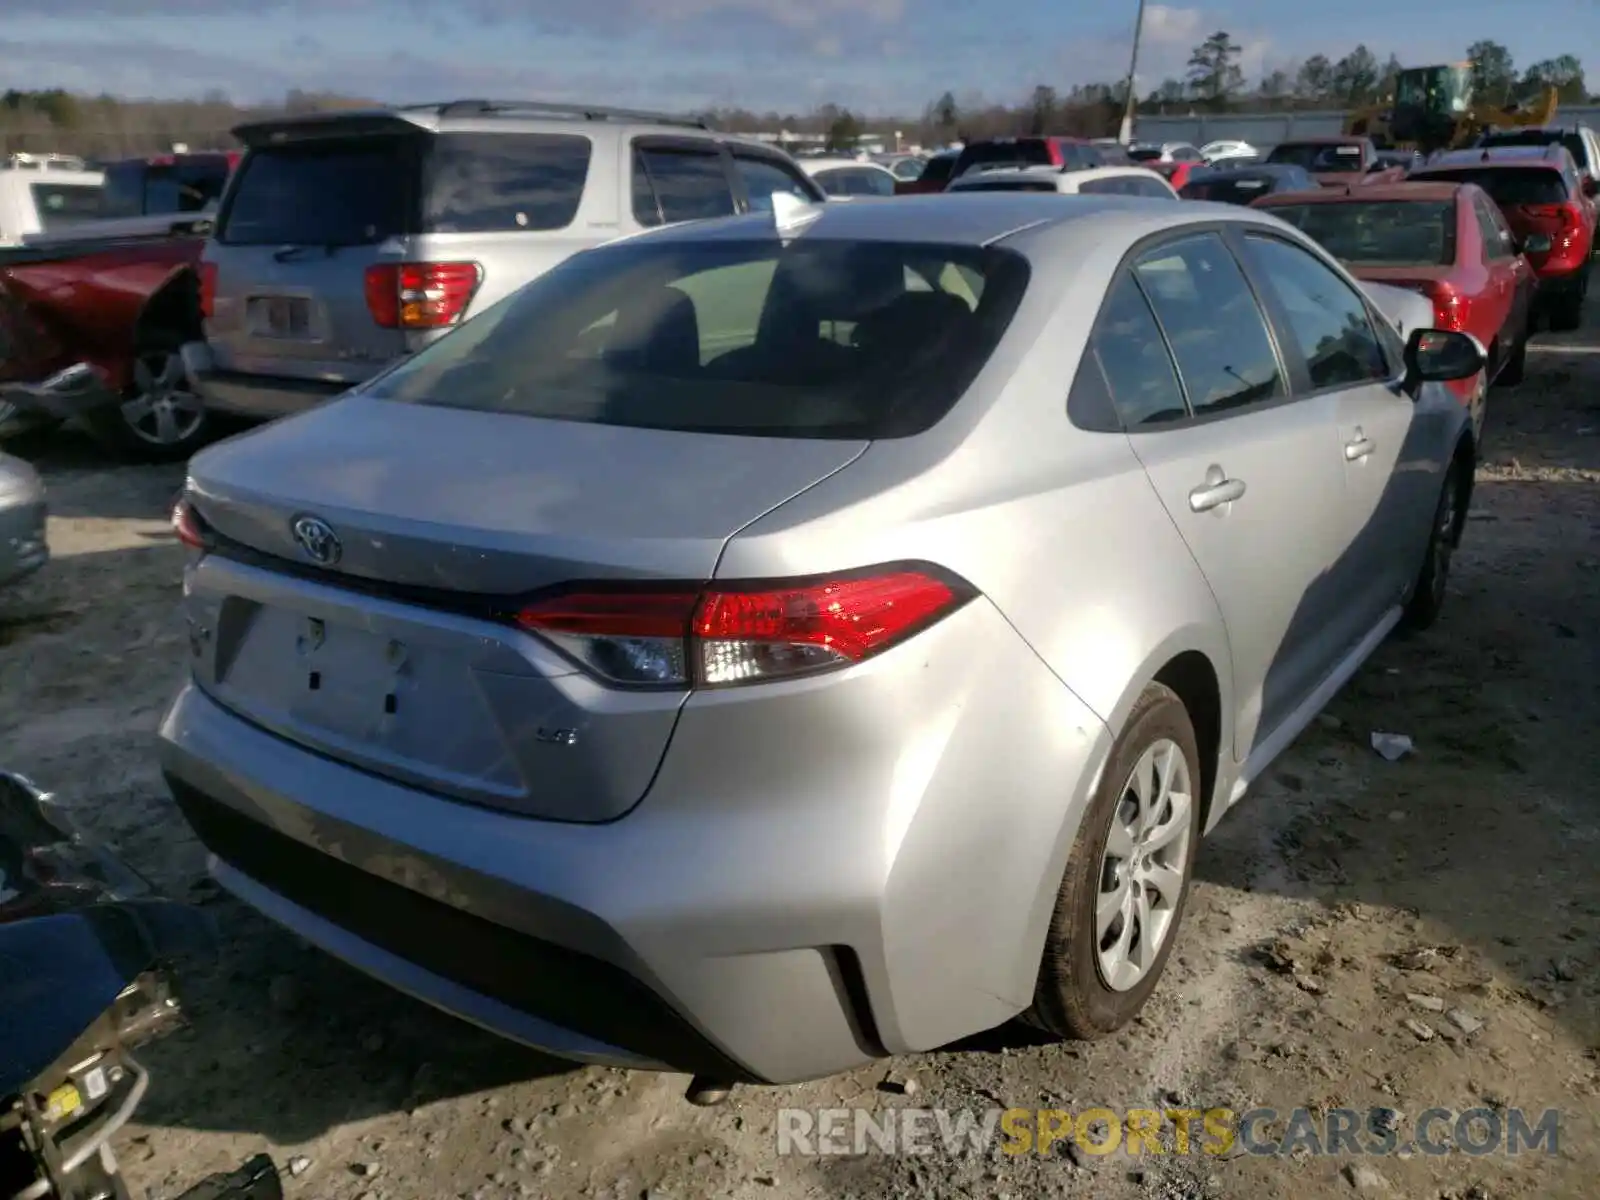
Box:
0;320;1600;1200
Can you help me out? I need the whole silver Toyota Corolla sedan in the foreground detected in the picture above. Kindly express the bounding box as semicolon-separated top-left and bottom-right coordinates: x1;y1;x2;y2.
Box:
162;194;1483;1082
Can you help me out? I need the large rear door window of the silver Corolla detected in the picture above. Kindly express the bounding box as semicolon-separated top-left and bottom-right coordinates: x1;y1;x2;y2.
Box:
1134;234;1288;416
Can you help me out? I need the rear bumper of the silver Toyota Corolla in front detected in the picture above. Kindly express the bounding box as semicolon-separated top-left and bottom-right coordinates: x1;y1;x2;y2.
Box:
160;600;1110;1083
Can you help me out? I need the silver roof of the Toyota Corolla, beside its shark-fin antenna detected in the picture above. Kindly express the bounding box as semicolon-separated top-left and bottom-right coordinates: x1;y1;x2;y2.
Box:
613;192;1278;250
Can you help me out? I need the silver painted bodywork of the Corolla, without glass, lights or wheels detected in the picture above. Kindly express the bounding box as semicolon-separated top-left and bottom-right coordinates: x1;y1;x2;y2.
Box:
160;194;1466;1082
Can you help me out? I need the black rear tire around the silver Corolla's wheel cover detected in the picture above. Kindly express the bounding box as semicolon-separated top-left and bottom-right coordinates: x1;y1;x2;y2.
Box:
1022;683;1202;1040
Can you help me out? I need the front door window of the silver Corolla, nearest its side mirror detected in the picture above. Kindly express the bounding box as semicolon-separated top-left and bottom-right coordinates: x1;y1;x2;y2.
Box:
1245;235;1389;389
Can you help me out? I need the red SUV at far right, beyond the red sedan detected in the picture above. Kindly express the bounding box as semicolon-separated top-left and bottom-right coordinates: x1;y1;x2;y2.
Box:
1410;146;1597;333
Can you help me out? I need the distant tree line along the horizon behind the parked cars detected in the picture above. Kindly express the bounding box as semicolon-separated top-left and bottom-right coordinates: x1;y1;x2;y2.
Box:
0;38;1590;158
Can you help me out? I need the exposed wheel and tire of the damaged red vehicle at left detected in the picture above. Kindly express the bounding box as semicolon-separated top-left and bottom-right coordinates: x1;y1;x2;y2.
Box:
80;330;216;462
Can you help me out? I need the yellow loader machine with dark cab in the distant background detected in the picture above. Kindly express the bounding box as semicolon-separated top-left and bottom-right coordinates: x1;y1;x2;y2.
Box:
1344;62;1558;154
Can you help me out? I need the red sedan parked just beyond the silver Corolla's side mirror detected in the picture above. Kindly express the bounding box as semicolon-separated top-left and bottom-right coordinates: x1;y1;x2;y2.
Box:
1251;182;1539;426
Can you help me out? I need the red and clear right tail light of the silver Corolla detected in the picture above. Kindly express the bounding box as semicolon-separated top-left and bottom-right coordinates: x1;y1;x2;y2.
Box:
515;565;976;688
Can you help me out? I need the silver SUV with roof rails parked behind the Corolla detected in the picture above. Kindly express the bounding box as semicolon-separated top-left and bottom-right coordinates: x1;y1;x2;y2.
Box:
184;101;824;418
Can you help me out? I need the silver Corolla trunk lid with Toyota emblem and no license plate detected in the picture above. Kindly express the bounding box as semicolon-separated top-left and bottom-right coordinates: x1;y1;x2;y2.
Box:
189;395;866;821
